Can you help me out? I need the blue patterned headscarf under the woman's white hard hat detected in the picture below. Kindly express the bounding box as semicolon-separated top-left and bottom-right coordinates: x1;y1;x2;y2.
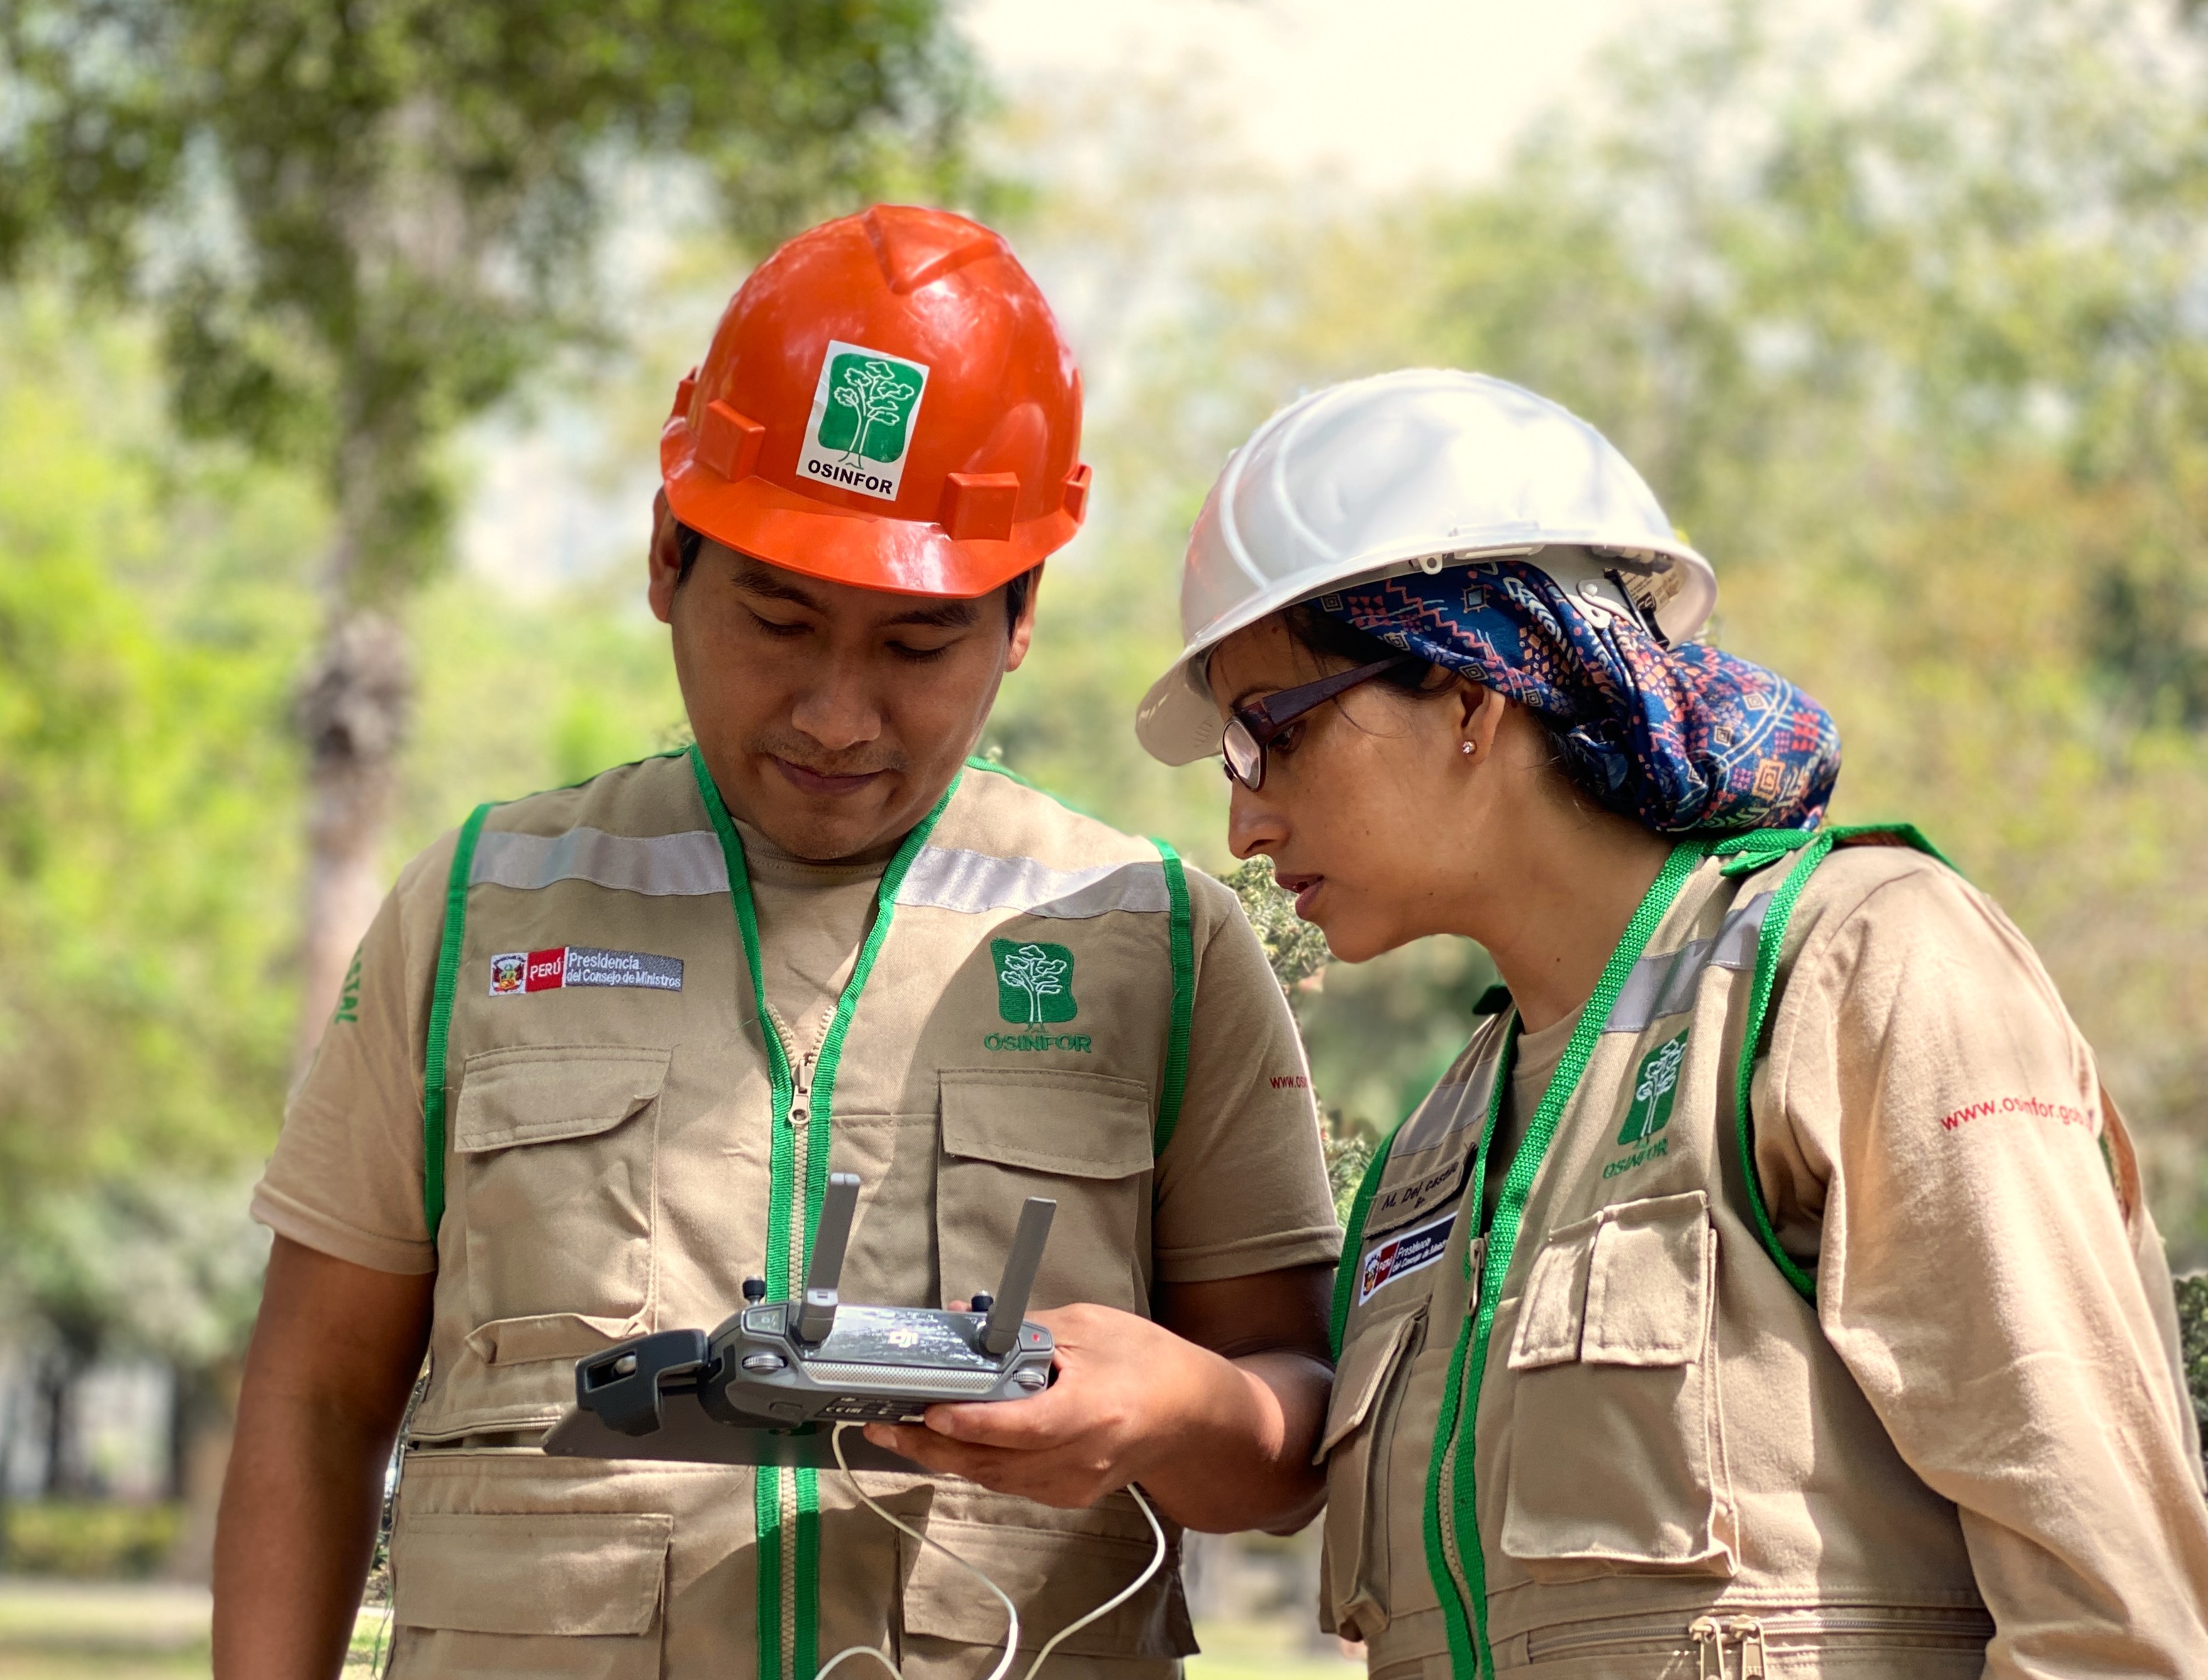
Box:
1312;561;1839;835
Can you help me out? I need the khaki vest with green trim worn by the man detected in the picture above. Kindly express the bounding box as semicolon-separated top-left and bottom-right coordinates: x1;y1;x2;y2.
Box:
393;748;1195;1680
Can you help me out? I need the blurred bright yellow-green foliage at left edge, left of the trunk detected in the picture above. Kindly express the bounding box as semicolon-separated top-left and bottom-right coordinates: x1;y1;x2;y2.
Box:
0;289;325;1552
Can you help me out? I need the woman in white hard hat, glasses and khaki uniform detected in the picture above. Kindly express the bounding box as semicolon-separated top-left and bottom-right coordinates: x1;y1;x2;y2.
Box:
1137;371;2208;1680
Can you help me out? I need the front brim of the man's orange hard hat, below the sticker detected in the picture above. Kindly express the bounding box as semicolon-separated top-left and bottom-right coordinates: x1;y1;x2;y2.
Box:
660;424;1079;601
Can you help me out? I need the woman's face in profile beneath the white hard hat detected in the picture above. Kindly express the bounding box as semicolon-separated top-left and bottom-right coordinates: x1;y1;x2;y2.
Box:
1210;618;1506;962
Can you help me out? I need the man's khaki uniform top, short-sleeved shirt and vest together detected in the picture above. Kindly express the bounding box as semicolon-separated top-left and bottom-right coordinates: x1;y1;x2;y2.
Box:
254;757;1341;1680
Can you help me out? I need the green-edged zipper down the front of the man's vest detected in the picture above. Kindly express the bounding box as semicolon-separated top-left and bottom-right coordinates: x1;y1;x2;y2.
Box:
689;744;958;1680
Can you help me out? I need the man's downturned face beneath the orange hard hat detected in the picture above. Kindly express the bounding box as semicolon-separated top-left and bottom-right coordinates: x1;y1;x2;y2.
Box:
651;503;1034;861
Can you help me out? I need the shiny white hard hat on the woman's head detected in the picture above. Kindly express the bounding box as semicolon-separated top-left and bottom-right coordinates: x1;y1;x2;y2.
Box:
1135;369;1718;764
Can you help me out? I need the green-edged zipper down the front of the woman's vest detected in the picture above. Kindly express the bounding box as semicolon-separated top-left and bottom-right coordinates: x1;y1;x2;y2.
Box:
1426;839;1709;1677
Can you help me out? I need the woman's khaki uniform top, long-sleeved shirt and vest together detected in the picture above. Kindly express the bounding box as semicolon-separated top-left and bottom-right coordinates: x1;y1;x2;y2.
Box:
1322;845;2208;1680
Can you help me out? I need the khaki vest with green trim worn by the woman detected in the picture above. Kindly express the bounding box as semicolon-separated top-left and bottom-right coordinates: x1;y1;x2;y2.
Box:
1320;830;1994;1680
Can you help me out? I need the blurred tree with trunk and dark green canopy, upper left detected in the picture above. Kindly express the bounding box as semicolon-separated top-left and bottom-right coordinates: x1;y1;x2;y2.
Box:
0;0;969;1051
